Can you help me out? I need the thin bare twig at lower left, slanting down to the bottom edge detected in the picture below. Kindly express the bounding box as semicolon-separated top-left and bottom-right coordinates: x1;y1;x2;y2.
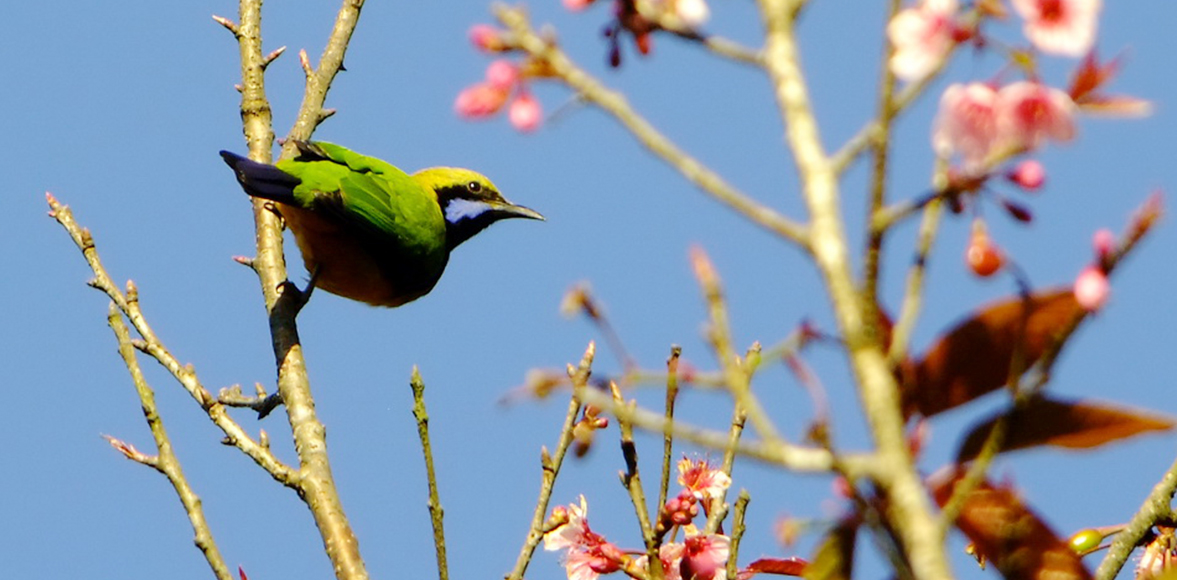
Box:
107;304;233;580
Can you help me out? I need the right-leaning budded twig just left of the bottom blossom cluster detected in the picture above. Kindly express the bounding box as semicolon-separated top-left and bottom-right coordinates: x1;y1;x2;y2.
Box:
505;342;597;580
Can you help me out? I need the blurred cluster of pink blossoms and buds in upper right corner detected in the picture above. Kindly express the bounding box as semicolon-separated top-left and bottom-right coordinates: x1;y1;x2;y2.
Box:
887;0;1149;287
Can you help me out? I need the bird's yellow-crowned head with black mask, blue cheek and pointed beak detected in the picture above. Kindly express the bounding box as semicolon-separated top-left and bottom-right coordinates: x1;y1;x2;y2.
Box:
413;167;544;249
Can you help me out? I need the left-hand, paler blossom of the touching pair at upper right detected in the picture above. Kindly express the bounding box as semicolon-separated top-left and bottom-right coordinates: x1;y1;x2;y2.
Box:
932;82;997;171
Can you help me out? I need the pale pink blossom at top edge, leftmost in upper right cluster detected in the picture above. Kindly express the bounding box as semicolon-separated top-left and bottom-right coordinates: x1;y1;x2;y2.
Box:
886;0;958;81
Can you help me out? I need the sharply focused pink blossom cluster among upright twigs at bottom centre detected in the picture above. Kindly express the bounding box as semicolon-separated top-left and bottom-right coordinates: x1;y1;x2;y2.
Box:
544;458;731;580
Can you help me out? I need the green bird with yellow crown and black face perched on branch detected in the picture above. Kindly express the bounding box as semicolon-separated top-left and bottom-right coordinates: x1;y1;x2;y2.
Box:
220;141;544;307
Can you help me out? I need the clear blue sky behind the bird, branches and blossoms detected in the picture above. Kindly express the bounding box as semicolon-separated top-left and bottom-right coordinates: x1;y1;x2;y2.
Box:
0;0;1177;579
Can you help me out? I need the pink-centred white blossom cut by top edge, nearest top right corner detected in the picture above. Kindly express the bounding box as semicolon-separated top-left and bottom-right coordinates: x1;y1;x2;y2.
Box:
1013;0;1100;56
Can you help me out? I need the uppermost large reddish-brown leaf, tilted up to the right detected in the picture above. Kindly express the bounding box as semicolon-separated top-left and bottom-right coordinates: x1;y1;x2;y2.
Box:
902;288;1084;416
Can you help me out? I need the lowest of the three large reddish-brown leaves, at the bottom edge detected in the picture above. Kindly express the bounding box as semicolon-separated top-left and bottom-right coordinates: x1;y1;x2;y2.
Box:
929;472;1091;580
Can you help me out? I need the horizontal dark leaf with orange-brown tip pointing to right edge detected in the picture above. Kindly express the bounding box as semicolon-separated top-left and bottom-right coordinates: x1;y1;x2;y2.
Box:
957;396;1175;461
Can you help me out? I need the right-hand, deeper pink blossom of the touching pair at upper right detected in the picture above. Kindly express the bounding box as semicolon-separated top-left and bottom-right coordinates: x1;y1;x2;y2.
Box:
996;81;1076;151
